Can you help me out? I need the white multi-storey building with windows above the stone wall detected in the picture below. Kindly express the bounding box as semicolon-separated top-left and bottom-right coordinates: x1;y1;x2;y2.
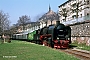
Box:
58;0;90;24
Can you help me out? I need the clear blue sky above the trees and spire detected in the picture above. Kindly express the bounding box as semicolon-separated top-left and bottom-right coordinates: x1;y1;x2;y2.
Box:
0;0;67;25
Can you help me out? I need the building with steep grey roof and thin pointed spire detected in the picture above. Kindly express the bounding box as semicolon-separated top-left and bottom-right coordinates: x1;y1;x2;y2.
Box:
39;5;58;28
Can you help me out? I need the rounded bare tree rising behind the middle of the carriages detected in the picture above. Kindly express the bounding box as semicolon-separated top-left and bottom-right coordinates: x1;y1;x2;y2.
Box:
18;15;31;30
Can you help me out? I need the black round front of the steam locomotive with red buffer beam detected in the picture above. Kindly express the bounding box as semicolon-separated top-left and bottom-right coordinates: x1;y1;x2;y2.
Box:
54;23;69;48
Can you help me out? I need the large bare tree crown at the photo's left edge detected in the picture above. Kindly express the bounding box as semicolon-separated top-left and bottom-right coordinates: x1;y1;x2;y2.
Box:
0;10;10;34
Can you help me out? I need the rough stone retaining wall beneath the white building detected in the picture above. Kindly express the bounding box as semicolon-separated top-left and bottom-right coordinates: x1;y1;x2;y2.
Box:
70;22;90;46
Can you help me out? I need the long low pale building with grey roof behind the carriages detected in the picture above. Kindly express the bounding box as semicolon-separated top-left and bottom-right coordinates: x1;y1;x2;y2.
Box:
17;22;40;33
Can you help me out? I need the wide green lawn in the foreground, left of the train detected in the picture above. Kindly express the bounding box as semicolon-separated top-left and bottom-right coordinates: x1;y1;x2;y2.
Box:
0;40;78;60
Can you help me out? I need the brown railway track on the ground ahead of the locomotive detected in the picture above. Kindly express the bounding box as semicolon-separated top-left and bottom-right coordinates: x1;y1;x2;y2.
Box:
61;49;90;60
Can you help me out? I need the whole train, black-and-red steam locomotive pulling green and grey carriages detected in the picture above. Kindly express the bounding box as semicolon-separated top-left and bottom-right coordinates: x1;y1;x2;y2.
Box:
13;21;71;48
